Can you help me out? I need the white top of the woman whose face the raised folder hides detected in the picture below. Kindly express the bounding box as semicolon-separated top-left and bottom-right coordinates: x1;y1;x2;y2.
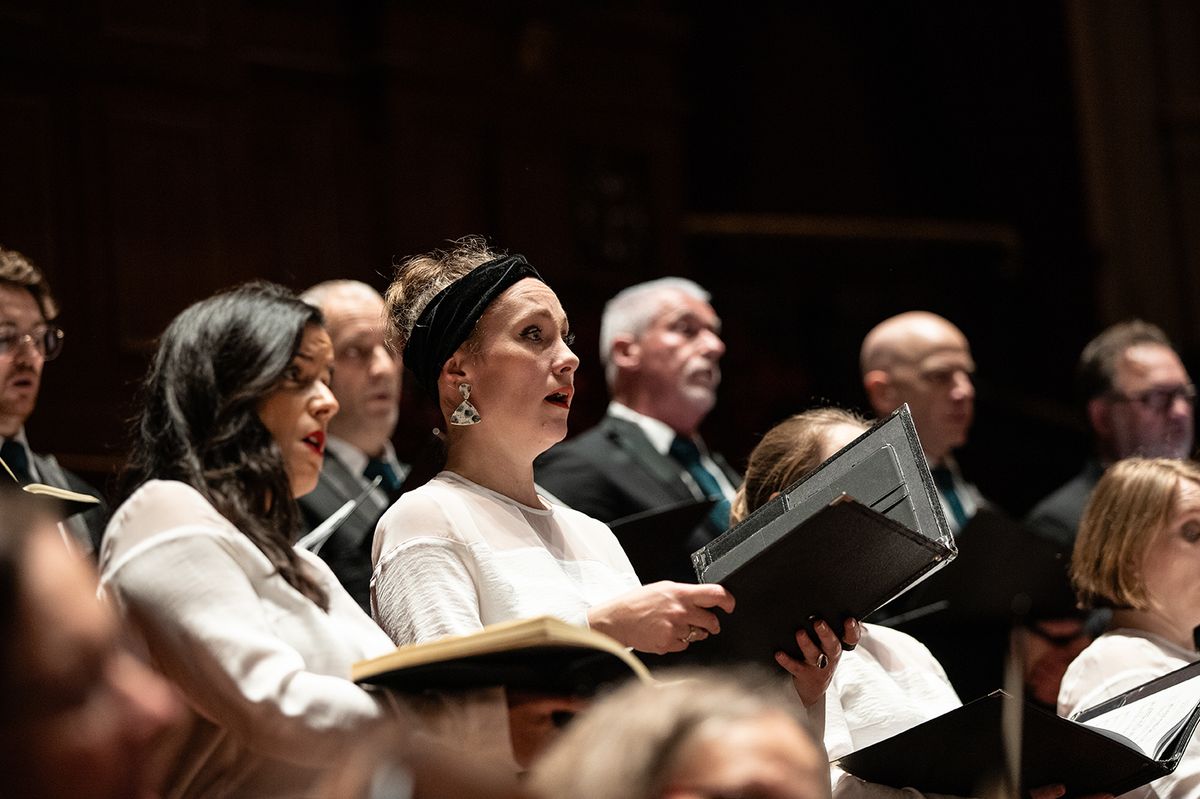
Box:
824;624;962;799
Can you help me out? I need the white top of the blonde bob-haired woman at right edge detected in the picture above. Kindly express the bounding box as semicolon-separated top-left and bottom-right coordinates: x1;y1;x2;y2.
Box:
1058;627;1200;799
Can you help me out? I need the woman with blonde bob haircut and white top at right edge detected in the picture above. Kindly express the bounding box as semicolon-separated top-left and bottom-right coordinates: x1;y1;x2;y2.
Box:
1058;458;1200;799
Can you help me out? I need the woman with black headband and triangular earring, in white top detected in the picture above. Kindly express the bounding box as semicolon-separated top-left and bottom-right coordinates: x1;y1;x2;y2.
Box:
372;238;852;763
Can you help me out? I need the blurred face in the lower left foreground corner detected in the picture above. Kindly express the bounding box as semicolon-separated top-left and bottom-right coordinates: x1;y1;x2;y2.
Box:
0;491;180;799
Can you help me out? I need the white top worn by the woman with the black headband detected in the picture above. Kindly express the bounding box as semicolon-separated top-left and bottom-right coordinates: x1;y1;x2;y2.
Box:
371;471;641;644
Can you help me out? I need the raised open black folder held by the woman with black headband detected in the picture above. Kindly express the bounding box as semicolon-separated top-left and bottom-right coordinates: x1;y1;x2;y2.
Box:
689;405;956;662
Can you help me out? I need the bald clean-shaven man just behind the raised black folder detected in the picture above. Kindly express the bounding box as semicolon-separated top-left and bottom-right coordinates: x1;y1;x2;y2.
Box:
860;311;984;535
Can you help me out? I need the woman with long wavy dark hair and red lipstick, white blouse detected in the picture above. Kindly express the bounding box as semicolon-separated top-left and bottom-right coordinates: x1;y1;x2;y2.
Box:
101;283;392;799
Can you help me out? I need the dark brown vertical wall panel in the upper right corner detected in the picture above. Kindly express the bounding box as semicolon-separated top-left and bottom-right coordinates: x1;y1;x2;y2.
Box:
1067;0;1200;353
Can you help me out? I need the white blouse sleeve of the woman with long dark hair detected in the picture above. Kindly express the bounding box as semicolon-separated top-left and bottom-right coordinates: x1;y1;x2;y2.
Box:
102;525;383;765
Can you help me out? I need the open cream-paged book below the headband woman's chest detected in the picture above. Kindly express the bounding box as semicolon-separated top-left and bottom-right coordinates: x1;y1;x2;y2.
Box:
350;615;650;695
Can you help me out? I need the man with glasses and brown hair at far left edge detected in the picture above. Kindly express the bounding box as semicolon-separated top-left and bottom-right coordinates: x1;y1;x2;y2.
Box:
0;247;107;553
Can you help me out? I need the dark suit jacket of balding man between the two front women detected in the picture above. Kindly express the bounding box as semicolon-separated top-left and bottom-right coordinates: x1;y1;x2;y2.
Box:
296;450;390;613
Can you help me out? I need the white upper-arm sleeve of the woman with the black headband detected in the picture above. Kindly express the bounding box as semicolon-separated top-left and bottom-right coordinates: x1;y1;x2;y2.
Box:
371;537;484;645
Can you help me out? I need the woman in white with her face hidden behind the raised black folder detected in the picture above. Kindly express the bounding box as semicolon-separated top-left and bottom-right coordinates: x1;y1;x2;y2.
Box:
730;408;1099;799
